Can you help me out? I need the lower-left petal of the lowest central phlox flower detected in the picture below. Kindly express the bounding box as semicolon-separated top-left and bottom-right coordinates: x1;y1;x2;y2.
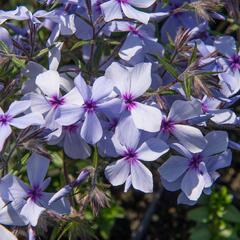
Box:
104;158;130;186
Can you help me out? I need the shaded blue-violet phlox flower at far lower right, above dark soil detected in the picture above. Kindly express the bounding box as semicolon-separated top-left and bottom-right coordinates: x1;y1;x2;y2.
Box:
159;131;232;203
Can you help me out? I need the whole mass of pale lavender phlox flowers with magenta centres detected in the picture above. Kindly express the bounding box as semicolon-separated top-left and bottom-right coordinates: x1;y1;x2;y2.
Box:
0;0;240;239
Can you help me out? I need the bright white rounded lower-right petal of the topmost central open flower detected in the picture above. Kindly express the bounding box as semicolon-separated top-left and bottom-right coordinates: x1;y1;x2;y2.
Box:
131;103;162;132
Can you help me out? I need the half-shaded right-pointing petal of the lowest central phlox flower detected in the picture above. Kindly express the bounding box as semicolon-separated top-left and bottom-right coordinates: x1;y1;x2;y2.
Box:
136;138;169;161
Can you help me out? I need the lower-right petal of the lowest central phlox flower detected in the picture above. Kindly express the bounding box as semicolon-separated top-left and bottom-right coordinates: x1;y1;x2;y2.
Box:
131;161;153;193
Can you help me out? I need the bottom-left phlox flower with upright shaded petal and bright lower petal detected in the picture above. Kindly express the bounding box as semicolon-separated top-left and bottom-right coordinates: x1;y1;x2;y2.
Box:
0;153;70;226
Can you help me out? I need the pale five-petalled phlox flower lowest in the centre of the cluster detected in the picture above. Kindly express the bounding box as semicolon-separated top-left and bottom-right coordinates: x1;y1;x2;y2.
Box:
105;118;169;193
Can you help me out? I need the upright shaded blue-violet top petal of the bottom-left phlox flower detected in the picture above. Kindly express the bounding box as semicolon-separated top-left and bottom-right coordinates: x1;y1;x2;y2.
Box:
27;153;50;187
